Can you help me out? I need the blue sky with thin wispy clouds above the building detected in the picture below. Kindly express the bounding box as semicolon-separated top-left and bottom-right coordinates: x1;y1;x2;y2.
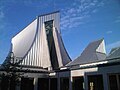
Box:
0;0;120;64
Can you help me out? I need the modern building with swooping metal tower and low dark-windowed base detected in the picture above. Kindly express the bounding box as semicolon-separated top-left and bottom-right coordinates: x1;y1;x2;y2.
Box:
1;11;120;90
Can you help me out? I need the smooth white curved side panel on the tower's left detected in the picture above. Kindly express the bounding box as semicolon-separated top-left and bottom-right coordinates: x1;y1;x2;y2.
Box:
12;19;37;57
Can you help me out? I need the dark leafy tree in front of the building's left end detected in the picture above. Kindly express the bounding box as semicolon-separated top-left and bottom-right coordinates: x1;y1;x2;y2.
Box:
0;52;23;90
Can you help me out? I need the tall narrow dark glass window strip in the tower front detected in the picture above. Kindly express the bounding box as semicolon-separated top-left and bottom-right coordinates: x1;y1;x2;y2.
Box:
45;20;58;69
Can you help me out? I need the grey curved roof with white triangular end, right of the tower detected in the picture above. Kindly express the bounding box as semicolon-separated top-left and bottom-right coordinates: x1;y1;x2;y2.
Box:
67;39;106;66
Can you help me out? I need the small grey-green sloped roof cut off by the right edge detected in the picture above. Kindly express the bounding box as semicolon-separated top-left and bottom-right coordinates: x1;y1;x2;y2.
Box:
106;47;120;59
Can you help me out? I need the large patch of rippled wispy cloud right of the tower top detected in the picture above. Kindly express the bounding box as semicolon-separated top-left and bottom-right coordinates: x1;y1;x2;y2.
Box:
61;0;104;30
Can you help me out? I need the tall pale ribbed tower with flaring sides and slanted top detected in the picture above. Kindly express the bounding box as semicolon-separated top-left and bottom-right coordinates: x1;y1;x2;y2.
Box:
12;11;71;70
